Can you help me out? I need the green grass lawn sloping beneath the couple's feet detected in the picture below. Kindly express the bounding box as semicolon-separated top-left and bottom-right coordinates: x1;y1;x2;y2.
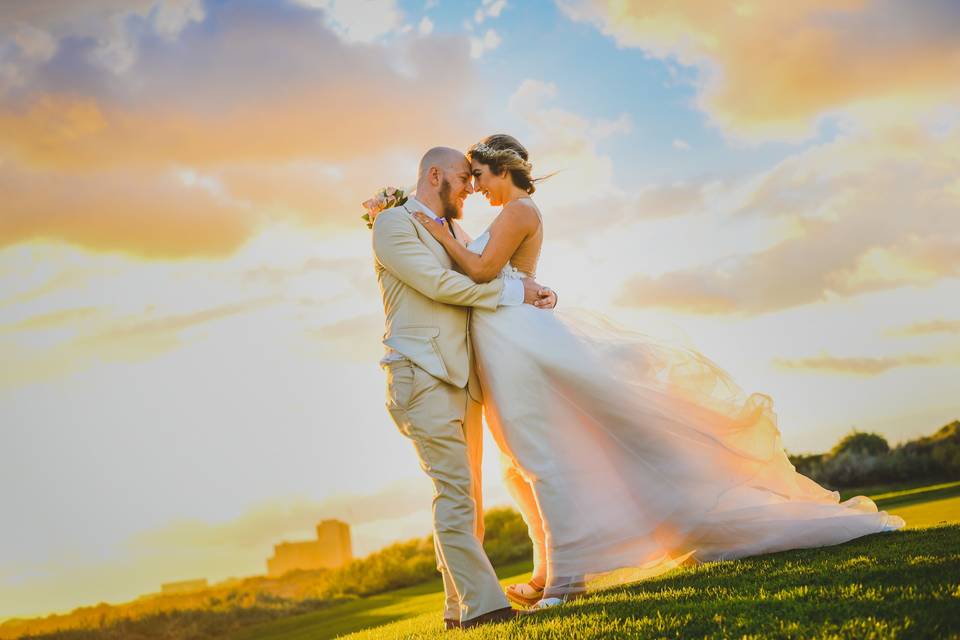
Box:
236;482;960;640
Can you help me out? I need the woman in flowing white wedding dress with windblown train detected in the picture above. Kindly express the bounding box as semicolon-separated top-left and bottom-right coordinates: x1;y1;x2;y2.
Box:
408;134;904;608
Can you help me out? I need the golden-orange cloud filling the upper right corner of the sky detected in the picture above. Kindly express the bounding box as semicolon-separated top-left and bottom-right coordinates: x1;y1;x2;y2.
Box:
557;0;960;141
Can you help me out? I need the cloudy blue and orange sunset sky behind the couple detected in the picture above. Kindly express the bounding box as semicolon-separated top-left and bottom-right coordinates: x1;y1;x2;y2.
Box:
0;0;960;619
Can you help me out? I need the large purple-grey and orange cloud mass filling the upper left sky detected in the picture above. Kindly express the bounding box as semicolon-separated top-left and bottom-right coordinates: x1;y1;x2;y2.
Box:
0;2;477;258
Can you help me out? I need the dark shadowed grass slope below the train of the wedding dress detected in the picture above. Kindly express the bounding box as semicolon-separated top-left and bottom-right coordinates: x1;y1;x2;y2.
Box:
524;526;960;637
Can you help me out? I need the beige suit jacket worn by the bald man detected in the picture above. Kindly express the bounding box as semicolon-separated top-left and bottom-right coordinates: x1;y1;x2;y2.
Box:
373;206;504;402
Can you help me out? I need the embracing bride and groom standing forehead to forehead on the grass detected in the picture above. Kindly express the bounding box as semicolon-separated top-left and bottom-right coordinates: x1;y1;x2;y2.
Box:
365;134;903;628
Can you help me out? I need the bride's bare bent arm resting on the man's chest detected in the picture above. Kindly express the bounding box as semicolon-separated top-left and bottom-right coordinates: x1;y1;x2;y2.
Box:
414;202;540;283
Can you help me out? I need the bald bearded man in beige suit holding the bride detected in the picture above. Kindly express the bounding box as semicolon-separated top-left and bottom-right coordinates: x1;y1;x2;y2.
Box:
373;147;556;629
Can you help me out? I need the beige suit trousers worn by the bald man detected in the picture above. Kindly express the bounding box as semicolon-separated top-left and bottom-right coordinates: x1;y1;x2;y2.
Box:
387;360;509;621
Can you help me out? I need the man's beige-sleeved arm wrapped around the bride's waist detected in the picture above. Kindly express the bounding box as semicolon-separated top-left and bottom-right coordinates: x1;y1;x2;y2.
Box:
373;213;504;310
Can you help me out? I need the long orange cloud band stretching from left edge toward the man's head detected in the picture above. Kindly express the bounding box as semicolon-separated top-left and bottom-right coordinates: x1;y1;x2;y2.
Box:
0;82;470;173
